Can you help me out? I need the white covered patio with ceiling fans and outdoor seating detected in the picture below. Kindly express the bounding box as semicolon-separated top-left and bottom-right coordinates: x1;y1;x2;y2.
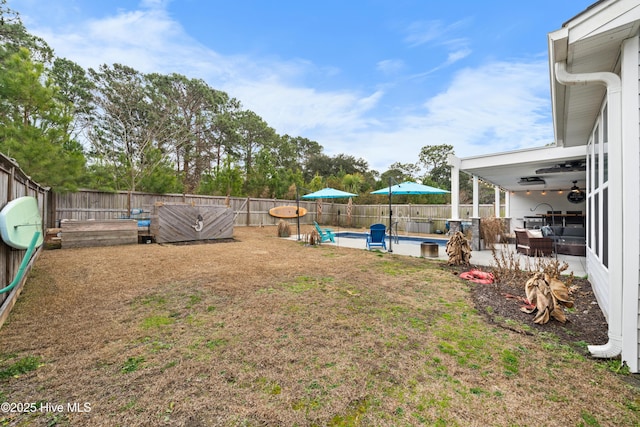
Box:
449;146;587;255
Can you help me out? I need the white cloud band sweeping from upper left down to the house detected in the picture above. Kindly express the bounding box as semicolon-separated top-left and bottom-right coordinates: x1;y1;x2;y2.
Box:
16;1;553;171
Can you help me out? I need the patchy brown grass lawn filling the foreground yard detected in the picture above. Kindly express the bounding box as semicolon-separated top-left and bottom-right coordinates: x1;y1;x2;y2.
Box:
0;227;640;426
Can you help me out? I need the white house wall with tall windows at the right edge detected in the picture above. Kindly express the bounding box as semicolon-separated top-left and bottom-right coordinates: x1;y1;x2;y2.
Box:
587;33;640;373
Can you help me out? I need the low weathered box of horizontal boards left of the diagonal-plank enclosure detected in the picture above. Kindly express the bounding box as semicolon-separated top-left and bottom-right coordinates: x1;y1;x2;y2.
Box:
60;219;138;249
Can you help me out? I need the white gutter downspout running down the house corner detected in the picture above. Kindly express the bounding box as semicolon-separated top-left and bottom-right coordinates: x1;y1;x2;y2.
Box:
555;61;624;358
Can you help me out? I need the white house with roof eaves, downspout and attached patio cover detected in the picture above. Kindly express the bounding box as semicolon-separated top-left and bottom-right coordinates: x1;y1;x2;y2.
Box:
450;0;640;372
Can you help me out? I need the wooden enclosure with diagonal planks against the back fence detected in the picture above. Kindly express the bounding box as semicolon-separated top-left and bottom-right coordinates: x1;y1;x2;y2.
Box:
151;203;234;243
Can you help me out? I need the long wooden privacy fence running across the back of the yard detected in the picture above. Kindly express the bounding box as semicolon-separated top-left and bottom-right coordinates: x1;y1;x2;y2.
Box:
48;190;502;232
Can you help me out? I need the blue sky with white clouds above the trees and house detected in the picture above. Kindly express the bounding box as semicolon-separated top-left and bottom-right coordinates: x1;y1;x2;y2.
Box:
8;0;595;172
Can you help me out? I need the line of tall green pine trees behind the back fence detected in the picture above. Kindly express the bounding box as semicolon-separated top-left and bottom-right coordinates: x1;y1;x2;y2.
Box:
0;0;493;203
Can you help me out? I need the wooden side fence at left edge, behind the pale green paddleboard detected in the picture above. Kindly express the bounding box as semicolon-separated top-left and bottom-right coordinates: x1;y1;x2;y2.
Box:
0;154;50;326
